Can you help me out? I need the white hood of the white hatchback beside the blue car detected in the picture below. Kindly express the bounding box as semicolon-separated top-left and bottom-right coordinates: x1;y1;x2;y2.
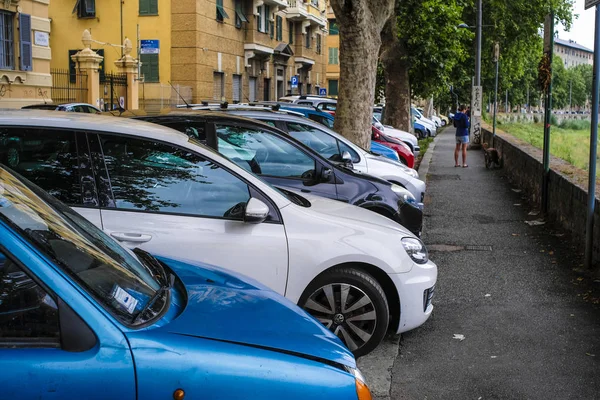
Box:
294;192;414;237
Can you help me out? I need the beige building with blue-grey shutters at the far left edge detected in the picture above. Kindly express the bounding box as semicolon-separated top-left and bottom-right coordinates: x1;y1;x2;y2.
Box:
0;0;52;108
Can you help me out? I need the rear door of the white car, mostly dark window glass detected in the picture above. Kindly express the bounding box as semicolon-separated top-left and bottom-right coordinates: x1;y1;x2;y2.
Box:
0;127;102;226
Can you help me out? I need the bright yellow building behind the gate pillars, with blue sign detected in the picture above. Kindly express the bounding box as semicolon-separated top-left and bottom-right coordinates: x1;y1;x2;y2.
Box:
50;0;171;109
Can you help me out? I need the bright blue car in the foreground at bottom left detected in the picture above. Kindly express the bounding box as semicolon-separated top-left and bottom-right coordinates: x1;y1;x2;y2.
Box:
0;166;371;400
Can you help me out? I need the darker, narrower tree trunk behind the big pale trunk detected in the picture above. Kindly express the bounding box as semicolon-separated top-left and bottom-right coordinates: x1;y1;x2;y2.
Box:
380;14;411;132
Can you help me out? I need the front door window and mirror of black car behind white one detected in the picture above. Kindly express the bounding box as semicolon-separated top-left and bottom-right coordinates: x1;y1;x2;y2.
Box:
215;122;337;200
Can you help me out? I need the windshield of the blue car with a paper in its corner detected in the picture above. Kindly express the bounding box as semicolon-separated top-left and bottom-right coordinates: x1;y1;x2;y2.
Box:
0;167;161;324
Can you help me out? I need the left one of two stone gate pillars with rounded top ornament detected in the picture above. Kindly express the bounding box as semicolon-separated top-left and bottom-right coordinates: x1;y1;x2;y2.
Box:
71;29;104;107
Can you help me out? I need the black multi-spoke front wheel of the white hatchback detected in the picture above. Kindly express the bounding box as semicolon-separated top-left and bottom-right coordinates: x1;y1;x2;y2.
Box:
298;268;390;357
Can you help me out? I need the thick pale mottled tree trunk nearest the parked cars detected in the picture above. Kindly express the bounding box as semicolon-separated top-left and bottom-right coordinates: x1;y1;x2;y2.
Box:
331;0;394;149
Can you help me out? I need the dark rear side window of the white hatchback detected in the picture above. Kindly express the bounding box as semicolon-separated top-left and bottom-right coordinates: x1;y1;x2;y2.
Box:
0;128;82;205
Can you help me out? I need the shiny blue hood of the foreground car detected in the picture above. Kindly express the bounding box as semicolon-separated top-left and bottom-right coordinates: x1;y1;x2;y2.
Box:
153;258;356;367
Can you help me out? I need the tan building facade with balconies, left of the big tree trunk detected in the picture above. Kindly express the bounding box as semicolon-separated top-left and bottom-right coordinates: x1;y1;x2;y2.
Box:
171;0;327;102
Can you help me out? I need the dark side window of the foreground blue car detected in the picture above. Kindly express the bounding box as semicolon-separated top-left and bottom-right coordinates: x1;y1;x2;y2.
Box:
0;250;60;347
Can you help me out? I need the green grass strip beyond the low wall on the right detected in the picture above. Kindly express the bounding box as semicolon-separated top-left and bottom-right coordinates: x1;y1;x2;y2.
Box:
502;120;600;171
